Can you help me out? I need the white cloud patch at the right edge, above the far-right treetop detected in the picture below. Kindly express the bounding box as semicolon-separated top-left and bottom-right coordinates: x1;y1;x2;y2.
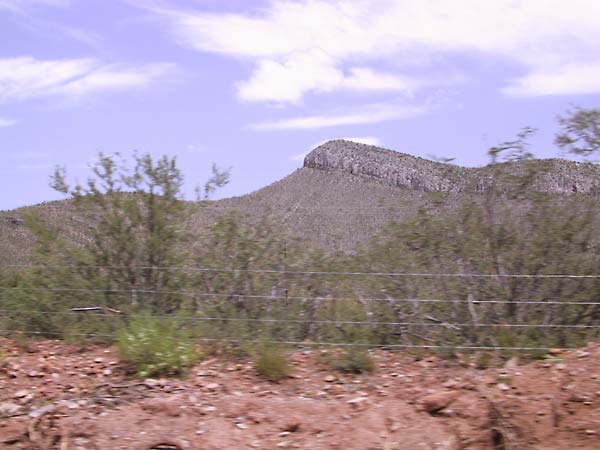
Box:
503;61;600;97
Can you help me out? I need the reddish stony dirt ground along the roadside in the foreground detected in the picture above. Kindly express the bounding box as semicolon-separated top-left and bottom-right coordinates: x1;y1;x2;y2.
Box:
0;339;600;450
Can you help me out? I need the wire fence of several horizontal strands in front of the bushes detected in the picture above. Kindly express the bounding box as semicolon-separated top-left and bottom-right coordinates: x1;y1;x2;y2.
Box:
0;264;600;351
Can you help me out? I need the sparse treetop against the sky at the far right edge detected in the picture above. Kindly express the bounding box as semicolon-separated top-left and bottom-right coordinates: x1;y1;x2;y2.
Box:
554;106;600;157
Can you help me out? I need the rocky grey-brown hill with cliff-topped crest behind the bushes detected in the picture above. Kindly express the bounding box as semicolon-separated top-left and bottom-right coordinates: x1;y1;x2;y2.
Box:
0;140;600;263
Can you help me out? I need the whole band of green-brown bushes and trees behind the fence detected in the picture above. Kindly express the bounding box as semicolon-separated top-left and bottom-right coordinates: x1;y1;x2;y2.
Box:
0;106;600;356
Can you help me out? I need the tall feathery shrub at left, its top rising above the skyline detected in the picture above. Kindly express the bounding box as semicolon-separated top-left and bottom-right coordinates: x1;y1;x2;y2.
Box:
51;153;187;310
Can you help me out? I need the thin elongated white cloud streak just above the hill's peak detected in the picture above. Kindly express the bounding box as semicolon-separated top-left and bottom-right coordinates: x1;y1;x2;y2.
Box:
249;103;431;131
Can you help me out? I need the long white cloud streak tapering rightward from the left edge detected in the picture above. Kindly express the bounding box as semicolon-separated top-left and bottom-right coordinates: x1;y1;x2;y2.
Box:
0;57;173;103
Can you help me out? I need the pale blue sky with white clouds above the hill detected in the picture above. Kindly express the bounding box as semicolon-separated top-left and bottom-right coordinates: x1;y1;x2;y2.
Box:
0;0;600;210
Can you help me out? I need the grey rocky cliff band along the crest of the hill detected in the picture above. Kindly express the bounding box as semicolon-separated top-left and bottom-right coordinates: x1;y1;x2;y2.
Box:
304;140;600;196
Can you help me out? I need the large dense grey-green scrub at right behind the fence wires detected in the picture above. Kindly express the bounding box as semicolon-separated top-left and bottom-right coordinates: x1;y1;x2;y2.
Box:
360;186;600;346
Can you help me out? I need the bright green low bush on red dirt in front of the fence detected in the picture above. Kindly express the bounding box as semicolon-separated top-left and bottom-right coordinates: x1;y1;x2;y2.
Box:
117;315;198;377
